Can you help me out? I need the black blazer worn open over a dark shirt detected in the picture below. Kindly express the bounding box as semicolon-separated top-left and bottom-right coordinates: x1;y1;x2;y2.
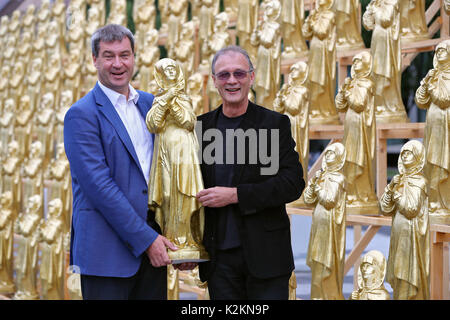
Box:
197;102;305;281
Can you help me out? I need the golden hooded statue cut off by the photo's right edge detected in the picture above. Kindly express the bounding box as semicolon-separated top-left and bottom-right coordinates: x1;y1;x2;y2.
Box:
416;40;450;224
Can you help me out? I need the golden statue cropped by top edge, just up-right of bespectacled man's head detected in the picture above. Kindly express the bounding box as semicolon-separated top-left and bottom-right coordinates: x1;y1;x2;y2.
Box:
281;0;308;59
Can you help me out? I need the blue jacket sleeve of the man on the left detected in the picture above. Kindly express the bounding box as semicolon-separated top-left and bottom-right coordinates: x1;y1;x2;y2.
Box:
64;106;158;257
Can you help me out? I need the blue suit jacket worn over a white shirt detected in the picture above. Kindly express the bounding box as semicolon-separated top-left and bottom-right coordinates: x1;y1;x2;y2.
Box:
64;84;158;277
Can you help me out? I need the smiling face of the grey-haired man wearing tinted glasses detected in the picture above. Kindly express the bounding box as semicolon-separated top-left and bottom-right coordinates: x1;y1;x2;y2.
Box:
213;51;255;105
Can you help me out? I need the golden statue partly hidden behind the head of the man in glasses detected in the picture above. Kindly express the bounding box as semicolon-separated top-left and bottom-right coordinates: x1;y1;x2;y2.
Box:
204;12;231;110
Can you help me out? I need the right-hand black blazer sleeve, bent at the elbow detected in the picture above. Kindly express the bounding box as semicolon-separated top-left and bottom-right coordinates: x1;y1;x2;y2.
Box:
237;115;305;215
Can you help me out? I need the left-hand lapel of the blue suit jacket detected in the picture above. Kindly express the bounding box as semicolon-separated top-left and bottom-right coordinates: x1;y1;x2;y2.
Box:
94;84;142;169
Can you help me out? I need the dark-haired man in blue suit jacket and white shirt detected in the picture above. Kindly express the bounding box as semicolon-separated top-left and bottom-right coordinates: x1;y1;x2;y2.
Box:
64;25;177;299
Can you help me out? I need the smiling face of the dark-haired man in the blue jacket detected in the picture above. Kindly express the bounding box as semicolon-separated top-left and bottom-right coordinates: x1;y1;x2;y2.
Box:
93;37;134;95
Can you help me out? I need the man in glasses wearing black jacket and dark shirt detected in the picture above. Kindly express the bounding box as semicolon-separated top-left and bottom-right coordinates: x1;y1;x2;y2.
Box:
197;46;304;299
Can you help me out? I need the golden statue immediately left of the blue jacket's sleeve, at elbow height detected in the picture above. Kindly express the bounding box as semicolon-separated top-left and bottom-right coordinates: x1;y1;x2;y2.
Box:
44;142;72;232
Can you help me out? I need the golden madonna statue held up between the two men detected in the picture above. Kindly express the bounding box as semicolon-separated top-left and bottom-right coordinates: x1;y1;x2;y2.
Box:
146;58;208;263
